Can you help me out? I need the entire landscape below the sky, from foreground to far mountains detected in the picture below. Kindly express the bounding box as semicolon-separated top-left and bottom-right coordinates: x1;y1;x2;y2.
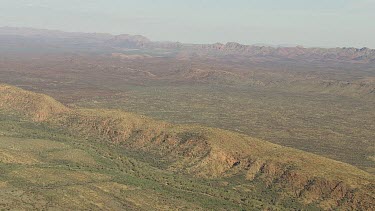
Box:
0;27;375;210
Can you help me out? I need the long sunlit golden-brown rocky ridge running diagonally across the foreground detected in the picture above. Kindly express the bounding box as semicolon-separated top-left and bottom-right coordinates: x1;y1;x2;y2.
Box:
0;85;375;210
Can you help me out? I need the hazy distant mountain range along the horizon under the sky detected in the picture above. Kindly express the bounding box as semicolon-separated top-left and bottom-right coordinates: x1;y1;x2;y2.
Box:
0;27;375;62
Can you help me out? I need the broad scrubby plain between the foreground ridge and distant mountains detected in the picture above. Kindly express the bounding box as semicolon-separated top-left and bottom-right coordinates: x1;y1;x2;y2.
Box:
0;52;375;172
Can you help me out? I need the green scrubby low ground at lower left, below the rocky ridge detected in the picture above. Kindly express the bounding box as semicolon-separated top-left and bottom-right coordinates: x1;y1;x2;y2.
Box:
0;115;304;210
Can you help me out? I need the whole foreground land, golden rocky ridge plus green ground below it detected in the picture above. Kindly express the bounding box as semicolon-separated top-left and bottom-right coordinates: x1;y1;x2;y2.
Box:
0;85;375;210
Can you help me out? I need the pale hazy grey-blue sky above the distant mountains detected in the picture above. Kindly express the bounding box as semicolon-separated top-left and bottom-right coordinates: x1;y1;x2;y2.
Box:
0;0;375;48
